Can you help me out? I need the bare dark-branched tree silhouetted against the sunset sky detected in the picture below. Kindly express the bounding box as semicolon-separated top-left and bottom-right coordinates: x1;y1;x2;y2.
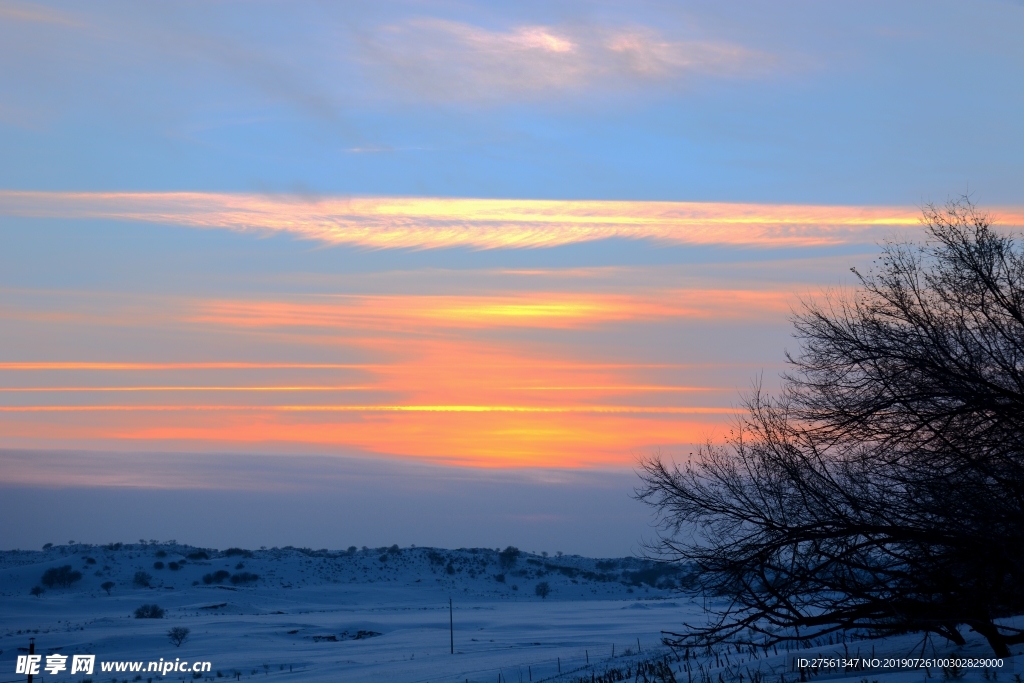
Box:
638;199;1024;656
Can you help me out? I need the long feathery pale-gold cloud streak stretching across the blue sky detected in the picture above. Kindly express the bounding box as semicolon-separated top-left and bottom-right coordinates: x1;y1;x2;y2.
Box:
6;190;1007;249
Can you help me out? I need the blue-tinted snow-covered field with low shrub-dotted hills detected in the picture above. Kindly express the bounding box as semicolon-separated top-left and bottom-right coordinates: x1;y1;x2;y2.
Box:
0;544;1024;683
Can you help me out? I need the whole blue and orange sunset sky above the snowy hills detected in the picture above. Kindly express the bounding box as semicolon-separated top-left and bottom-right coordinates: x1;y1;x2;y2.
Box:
0;0;1024;556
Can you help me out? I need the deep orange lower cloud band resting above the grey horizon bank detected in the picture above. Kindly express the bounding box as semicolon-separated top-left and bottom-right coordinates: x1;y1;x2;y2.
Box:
0;327;735;468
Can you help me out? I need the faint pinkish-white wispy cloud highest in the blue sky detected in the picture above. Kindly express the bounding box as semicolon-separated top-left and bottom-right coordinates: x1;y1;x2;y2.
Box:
360;18;777;102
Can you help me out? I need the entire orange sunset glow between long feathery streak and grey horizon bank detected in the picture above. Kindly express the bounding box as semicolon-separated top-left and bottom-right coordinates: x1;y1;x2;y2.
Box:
0;255;792;471
